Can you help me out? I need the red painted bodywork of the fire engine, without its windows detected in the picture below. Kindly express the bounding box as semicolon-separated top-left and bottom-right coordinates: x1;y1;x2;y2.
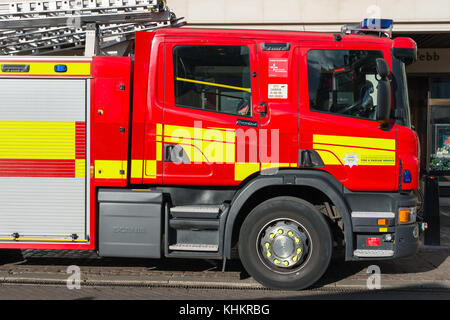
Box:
2;29;419;250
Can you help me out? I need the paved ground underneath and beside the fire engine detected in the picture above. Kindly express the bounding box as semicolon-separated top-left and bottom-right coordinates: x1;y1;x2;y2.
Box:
0;208;450;292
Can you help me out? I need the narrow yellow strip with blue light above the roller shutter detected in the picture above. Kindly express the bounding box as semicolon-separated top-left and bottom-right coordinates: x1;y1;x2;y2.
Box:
0;61;91;76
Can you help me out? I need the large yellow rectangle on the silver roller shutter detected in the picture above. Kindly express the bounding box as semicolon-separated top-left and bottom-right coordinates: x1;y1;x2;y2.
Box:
0;121;75;160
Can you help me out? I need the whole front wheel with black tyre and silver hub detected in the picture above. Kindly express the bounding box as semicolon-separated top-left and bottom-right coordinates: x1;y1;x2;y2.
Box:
239;197;332;290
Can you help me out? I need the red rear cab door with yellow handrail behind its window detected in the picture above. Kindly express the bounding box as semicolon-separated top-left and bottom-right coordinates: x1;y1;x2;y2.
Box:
161;38;260;186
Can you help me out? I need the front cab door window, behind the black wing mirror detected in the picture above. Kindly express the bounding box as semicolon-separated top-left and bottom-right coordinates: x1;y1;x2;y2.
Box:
307;50;383;120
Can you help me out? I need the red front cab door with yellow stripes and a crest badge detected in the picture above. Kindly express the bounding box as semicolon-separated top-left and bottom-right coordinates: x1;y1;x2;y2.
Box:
300;39;398;191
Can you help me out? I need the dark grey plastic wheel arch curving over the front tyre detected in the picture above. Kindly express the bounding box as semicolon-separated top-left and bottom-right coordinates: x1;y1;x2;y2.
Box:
224;169;353;259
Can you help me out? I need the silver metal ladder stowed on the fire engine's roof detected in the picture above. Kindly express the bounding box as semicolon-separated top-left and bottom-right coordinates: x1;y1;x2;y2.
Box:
0;0;185;56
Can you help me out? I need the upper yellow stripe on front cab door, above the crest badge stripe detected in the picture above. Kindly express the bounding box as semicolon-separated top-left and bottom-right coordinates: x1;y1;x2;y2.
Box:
313;134;395;151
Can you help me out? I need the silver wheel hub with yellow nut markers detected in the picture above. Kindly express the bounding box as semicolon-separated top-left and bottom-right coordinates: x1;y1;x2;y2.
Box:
260;220;308;268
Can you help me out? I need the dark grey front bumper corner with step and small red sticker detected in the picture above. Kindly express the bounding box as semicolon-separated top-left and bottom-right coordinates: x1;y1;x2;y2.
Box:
346;192;419;260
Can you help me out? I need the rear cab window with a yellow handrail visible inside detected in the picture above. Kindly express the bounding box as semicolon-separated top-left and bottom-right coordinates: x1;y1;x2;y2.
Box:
173;45;252;116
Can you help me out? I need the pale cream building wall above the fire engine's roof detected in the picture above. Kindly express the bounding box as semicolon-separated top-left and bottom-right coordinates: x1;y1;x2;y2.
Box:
0;0;450;32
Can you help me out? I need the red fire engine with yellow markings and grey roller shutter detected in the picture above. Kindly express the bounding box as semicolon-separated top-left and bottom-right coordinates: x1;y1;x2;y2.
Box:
0;1;419;289
